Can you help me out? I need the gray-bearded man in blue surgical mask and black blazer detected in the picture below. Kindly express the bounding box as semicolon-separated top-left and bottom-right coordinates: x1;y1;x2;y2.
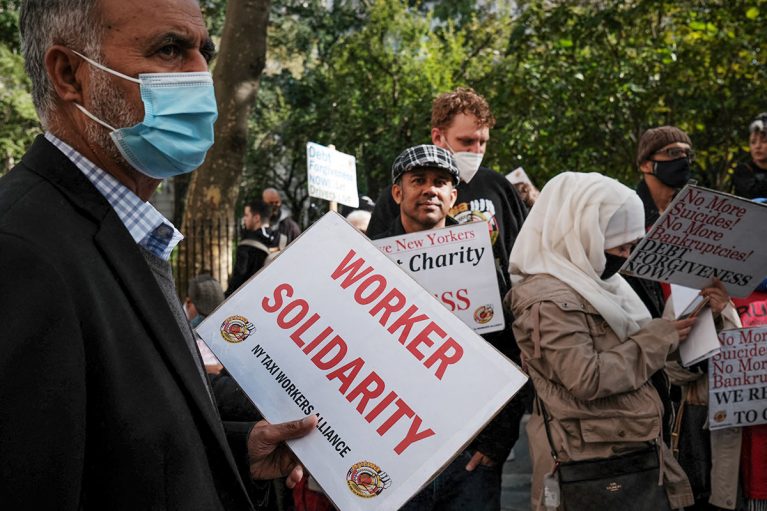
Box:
0;0;316;511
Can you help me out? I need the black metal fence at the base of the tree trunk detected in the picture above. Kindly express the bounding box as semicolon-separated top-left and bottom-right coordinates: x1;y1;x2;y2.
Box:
171;218;237;300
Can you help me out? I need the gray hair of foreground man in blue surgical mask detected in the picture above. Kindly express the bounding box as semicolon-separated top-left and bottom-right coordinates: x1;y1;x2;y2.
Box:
19;0;102;127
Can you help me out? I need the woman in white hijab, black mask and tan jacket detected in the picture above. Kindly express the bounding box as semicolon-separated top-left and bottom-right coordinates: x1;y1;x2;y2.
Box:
509;172;694;511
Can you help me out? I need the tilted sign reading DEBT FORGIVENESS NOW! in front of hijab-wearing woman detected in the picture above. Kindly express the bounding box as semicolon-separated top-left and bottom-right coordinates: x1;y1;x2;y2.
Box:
621;185;767;296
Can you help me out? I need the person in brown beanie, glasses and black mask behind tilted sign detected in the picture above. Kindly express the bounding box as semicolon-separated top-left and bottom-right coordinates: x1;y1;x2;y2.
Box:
626;126;752;510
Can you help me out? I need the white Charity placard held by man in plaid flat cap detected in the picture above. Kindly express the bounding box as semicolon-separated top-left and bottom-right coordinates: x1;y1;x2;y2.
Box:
373;222;504;334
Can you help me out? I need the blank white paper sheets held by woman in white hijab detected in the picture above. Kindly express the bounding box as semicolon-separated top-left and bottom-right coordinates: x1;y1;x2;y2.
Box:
671;284;721;367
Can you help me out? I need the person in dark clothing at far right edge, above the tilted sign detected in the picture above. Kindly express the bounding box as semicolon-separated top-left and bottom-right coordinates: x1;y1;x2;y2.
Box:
732;112;767;199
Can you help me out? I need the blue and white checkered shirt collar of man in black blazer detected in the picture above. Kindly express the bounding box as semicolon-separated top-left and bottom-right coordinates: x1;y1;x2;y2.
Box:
45;132;184;261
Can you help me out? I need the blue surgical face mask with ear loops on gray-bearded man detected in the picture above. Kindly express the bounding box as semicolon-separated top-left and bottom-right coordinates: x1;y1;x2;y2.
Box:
73;50;218;179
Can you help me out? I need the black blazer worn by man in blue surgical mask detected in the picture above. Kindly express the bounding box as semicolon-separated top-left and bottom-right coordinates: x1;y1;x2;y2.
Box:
0;137;251;511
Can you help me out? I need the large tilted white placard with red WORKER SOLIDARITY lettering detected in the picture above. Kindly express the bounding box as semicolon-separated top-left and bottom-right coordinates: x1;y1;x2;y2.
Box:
197;212;526;511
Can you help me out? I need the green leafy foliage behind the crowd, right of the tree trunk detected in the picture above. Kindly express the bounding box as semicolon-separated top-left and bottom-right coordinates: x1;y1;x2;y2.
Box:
243;0;767;219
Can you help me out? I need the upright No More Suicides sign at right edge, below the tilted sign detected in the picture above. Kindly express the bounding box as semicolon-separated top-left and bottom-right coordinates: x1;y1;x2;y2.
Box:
708;326;767;430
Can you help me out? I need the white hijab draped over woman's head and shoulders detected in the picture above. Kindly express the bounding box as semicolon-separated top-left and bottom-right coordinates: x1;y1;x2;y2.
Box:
509;172;650;340
